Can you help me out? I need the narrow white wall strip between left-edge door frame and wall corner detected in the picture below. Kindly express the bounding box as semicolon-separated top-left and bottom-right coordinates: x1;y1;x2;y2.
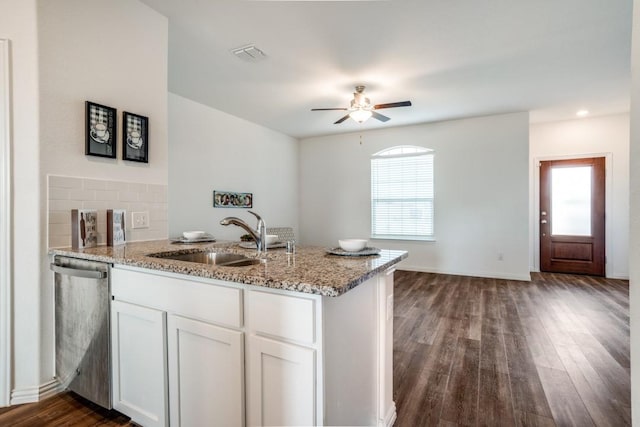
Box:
0;0;42;404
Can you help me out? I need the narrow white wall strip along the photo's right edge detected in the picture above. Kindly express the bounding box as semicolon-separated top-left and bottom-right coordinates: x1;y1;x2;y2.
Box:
629;0;640;426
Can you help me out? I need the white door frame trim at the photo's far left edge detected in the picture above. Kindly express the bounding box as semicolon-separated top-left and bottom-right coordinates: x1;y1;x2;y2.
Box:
0;39;13;407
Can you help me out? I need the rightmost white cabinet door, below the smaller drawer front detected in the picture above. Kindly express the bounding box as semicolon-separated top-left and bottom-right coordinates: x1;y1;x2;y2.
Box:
247;336;316;426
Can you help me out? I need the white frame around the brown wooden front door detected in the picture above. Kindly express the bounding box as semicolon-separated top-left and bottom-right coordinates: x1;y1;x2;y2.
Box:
531;152;614;277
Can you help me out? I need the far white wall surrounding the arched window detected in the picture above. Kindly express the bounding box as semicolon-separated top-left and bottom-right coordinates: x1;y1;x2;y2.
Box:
300;113;529;280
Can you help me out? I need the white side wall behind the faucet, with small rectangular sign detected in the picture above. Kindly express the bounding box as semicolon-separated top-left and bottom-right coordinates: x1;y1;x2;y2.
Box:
169;93;298;240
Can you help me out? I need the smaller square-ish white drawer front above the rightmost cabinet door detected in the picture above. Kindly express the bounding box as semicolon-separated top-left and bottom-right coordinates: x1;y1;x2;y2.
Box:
246;291;317;344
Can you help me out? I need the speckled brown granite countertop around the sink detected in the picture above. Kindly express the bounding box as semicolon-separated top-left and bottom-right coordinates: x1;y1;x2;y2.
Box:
49;240;408;297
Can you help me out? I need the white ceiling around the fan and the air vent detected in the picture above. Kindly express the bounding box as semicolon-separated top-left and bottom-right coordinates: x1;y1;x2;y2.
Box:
142;0;633;138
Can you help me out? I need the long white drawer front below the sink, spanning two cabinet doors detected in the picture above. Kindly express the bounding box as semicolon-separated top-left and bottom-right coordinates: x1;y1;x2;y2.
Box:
111;268;243;328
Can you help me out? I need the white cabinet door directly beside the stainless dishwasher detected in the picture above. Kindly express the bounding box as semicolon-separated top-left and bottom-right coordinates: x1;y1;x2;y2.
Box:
111;301;168;427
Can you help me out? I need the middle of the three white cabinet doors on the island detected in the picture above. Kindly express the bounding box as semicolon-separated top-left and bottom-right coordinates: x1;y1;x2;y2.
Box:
167;315;244;427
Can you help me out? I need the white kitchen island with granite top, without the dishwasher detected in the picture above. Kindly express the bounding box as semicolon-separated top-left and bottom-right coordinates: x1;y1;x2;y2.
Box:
51;241;407;426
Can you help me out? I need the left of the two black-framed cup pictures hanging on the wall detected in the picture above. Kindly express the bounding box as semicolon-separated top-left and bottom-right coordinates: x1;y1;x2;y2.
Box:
84;101;117;159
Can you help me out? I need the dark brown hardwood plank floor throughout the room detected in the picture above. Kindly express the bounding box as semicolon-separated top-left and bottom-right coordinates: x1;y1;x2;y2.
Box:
0;271;631;427
